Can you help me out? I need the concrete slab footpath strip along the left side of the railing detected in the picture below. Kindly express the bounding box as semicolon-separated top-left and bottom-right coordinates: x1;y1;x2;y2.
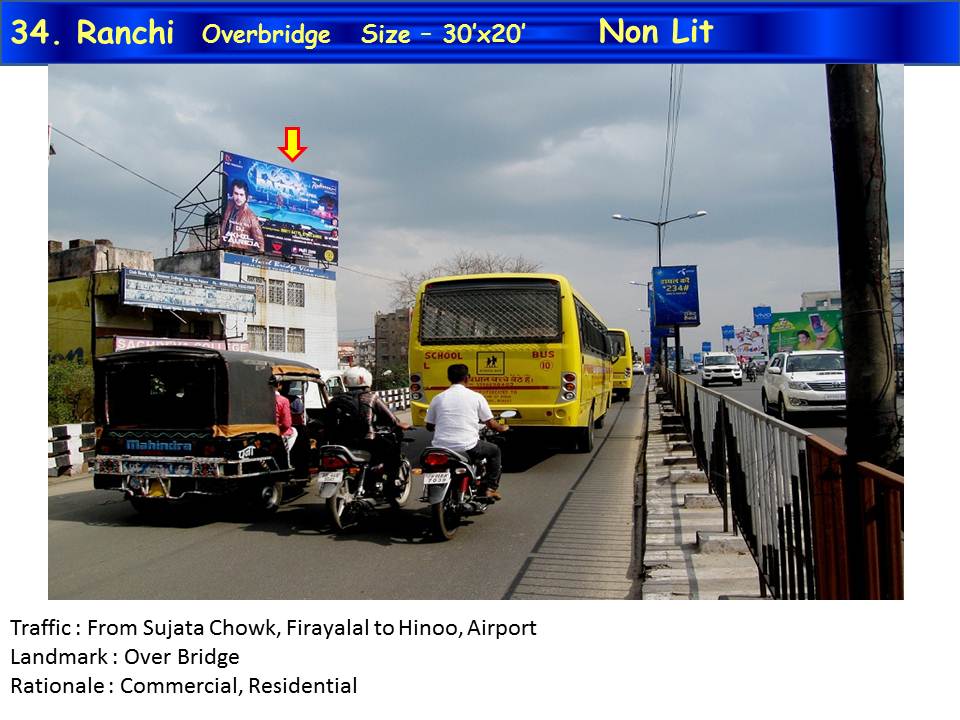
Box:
641;382;760;600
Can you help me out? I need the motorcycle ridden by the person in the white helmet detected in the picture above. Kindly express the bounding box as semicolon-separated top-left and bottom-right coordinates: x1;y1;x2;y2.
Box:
317;429;413;531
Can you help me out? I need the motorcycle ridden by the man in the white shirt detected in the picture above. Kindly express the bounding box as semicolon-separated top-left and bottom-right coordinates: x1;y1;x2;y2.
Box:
419;410;517;540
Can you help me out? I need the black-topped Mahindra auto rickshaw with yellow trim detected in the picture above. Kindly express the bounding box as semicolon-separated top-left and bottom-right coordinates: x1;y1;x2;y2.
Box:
94;347;328;512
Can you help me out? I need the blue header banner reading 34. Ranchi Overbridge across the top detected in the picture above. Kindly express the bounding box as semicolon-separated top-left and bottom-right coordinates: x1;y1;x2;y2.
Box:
0;2;960;65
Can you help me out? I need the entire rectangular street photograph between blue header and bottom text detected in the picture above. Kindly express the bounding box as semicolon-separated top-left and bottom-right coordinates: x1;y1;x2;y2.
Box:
47;64;904;600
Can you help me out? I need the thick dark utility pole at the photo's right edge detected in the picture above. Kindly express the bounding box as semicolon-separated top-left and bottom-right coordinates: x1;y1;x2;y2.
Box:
826;65;899;468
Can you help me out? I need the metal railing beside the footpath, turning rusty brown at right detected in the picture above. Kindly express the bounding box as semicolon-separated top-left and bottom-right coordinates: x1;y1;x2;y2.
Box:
662;371;903;599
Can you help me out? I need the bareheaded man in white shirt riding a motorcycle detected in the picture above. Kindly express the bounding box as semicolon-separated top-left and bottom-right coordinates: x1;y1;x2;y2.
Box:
427;364;510;501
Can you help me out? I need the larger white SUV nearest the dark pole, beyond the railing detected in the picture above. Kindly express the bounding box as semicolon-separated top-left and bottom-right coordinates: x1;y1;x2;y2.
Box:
760;350;847;422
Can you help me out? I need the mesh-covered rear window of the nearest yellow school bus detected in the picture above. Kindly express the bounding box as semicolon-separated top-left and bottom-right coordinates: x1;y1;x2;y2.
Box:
420;281;561;345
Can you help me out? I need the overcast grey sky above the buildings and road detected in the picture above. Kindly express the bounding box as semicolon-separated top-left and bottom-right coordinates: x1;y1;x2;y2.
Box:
49;65;903;352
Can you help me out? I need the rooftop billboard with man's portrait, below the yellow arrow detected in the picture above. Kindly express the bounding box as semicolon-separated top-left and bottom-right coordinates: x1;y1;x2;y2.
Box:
220;151;340;263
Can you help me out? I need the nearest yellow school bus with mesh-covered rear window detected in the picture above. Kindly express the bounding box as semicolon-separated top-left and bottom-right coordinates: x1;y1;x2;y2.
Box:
409;273;613;452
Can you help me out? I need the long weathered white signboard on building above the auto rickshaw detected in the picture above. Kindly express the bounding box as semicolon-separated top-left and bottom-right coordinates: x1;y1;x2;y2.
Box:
120;268;257;314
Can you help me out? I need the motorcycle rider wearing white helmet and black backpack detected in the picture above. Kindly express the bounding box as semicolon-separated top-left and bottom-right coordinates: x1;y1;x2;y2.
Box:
334;367;411;498
